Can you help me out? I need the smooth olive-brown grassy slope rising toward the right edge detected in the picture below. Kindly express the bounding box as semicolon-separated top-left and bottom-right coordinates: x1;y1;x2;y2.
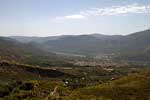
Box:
67;71;150;100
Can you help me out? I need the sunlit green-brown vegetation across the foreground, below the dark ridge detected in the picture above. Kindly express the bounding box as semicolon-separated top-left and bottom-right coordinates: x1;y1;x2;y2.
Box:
0;65;150;100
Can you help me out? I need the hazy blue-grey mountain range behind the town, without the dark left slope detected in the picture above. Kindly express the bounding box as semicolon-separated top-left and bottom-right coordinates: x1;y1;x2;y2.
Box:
10;30;150;60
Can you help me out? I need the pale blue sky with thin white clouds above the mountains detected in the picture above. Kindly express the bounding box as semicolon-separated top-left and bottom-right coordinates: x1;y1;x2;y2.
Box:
0;0;150;36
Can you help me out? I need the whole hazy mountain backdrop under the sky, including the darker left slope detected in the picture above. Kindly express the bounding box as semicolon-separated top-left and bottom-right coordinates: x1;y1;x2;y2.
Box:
0;30;150;65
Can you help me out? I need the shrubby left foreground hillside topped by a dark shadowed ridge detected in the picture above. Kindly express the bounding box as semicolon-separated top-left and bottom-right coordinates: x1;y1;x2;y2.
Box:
0;61;76;100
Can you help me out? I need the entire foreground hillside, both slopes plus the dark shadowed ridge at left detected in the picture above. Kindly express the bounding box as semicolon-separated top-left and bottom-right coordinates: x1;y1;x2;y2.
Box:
0;59;150;100
